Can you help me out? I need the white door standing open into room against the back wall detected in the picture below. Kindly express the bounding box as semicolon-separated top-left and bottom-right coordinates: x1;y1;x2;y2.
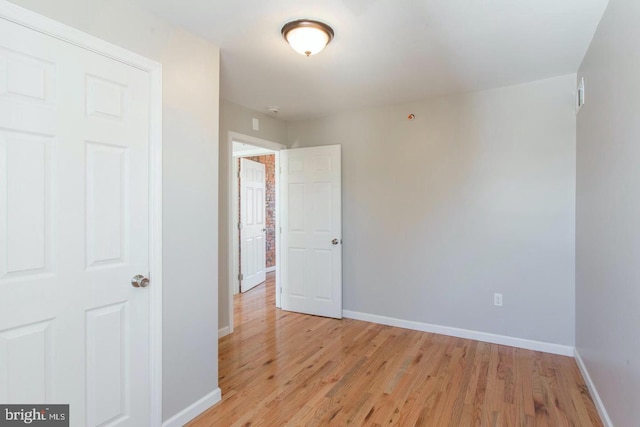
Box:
280;145;342;319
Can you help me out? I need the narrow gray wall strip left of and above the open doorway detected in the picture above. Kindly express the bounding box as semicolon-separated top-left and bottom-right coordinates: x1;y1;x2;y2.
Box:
218;100;287;328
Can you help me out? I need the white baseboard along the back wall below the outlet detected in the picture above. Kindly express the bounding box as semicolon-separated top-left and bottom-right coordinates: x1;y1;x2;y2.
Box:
342;310;574;356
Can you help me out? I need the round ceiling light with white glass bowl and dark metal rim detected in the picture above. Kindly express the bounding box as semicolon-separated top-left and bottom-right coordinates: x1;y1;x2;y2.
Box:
282;19;333;56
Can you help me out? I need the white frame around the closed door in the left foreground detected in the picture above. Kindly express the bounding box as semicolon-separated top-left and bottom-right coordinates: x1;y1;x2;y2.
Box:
0;0;162;426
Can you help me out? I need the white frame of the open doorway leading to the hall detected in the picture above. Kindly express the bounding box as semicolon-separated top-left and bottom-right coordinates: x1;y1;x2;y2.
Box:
225;131;288;337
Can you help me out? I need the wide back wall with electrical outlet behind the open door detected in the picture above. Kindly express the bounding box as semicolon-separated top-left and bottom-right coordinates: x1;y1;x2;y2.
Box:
289;75;575;346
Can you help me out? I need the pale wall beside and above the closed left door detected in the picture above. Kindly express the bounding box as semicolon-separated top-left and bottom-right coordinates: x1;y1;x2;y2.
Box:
5;0;219;420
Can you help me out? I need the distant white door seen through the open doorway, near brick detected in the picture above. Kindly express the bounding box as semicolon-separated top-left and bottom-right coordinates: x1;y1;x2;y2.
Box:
240;158;267;292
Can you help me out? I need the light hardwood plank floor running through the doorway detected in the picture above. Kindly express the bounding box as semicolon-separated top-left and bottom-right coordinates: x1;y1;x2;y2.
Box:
189;275;602;427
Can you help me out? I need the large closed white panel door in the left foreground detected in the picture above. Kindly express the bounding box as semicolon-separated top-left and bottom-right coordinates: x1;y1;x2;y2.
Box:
0;19;150;427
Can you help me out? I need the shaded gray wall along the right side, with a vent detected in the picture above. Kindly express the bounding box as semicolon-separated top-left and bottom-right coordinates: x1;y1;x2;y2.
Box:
576;0;640;426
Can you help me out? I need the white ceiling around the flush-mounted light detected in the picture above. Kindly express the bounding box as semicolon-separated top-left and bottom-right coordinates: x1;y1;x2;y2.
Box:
129;0;608;120
